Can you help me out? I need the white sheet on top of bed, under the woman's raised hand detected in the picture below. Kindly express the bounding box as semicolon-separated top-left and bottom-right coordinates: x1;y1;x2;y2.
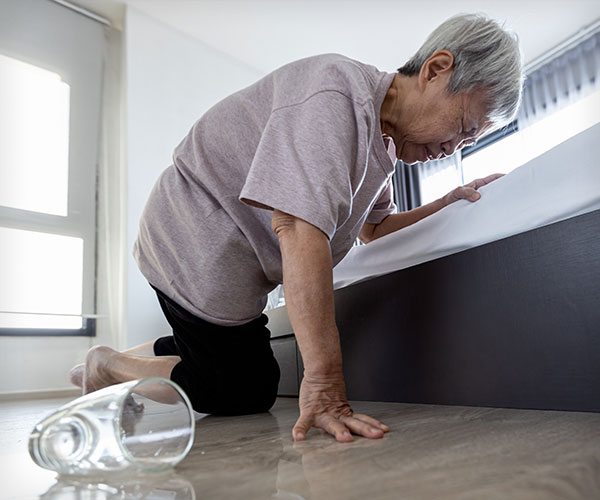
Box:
333;124;600;289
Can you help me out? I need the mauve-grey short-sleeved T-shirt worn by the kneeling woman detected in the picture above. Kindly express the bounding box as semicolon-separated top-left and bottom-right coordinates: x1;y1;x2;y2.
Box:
134;54;396;325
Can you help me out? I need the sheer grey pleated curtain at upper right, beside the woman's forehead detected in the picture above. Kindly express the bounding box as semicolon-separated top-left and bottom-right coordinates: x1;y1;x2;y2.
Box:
517;33;600;130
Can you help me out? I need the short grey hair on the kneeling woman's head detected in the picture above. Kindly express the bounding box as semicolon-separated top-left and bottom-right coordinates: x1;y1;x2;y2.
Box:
398;14;524;128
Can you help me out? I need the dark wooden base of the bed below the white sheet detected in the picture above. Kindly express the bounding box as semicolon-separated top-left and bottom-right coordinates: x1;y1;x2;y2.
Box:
268;210;600;412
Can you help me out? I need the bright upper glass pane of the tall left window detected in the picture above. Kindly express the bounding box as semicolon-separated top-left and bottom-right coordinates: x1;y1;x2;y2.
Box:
0;54;70;216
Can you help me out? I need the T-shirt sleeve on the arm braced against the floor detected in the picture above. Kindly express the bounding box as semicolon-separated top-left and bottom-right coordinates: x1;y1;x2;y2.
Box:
239;91;366;239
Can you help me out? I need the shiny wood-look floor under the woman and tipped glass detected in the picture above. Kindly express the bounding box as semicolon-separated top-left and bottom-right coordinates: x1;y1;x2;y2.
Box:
0;399;600;500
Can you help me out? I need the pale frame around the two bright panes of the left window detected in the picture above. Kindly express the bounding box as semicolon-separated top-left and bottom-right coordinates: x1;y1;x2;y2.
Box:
0;0;106;337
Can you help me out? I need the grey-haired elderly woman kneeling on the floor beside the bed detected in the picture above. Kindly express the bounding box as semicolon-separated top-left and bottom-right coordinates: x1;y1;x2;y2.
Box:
71;11;523;441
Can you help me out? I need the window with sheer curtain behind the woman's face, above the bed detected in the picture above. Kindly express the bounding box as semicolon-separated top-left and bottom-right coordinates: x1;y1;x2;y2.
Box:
411;27;600;207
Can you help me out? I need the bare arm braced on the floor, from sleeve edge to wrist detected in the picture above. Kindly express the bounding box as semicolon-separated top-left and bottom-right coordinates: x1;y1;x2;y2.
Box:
274;214;342;378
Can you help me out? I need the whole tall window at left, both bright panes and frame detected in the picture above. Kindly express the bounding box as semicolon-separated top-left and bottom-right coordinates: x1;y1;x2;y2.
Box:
0;0;104;335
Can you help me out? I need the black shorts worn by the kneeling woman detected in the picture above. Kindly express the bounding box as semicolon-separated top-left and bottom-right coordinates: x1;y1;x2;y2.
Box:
152;287;279;415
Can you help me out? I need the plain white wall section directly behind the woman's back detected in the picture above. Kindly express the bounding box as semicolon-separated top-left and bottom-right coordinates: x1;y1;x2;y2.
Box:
122;7;263;347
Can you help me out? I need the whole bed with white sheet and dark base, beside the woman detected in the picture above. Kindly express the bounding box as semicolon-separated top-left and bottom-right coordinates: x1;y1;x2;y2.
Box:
269;125;600;411
